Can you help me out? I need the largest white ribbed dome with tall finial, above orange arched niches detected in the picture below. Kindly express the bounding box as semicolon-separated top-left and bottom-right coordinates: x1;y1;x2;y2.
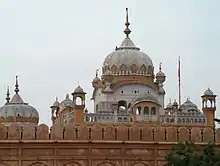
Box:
103;9;154;75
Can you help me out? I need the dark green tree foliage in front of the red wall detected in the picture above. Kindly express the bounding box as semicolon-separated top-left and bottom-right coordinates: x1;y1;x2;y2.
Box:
165;142;220;166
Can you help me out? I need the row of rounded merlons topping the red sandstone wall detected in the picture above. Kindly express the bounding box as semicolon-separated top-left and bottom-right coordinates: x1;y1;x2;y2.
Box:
0;124;220;143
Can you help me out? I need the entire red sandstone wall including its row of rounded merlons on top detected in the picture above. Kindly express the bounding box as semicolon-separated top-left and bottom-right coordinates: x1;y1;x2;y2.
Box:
0;124;220;166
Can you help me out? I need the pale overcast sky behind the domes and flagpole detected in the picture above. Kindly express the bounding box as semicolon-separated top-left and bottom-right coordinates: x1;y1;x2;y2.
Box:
0;0;220;124
